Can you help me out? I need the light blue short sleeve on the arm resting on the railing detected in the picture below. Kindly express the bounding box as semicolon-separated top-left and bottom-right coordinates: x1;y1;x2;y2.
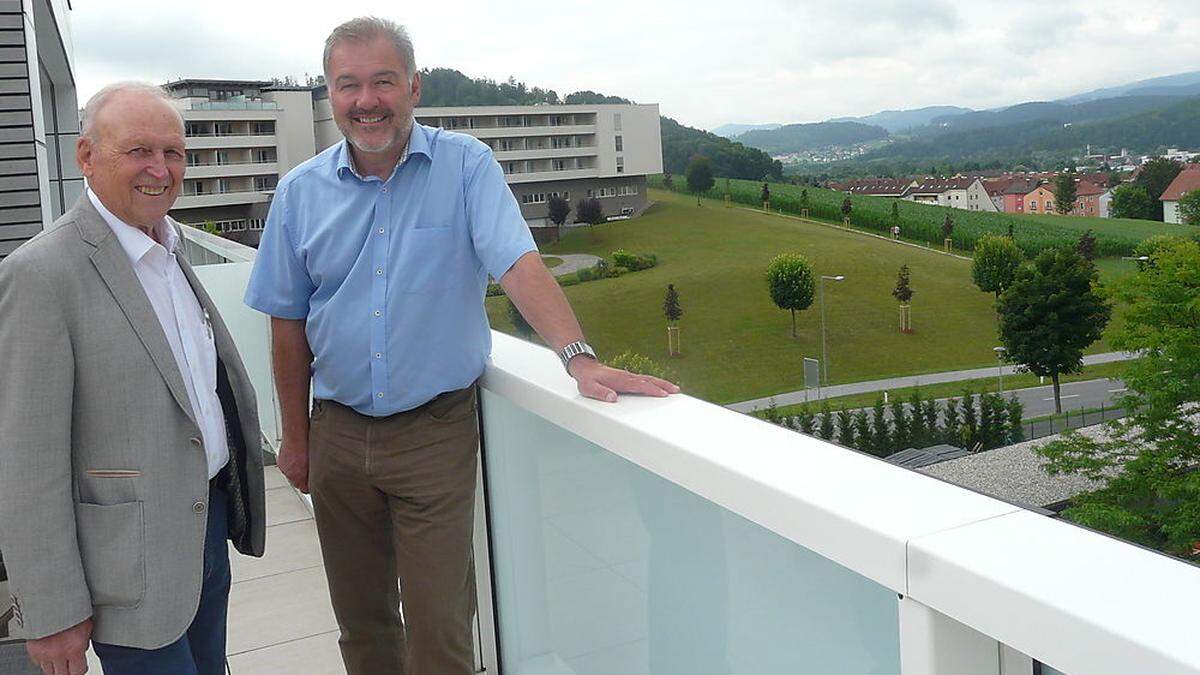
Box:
463;144;538;280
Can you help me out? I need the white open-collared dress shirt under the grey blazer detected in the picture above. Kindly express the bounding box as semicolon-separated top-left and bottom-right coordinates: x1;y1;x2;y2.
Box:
88;189;229;479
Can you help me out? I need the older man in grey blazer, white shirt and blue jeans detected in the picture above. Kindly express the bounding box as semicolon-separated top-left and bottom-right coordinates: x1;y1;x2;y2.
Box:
0;83;265;675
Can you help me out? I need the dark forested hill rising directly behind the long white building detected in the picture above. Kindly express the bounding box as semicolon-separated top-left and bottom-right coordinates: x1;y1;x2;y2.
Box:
421;68;782;180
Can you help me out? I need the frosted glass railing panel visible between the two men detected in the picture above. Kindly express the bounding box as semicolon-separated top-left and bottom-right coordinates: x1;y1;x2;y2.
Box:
193;263;280;449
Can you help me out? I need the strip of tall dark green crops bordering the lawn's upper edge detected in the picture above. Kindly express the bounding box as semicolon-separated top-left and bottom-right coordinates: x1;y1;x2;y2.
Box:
652;174;1195;256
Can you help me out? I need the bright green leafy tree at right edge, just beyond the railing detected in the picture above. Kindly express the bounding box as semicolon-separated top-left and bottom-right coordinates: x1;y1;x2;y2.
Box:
1037;241;1200;556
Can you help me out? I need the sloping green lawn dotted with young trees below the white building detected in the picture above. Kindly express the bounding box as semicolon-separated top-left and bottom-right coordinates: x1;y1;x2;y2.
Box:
487;190;1128;402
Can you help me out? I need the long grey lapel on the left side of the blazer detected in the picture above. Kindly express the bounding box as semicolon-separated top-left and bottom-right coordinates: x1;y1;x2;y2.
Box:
74;193;199;426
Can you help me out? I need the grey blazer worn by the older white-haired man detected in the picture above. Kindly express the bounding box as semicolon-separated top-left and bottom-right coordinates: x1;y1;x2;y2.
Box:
0;195;265;649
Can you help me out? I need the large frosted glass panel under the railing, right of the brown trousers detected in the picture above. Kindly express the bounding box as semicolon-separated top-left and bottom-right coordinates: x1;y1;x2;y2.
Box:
482;390;900;675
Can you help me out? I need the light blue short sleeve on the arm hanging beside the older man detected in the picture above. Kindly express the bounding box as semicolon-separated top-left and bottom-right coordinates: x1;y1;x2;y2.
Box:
245;186;316;319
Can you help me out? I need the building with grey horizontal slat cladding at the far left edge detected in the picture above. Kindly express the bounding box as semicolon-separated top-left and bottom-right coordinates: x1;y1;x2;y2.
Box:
0;0;83;263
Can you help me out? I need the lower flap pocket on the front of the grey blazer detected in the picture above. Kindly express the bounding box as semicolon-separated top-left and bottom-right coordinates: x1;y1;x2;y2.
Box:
76;502;146;609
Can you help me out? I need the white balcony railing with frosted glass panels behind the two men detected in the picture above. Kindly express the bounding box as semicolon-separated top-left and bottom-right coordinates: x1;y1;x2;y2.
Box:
177;224;1200;675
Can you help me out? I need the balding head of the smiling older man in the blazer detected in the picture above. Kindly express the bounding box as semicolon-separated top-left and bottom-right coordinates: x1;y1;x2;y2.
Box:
76;83;187;234
